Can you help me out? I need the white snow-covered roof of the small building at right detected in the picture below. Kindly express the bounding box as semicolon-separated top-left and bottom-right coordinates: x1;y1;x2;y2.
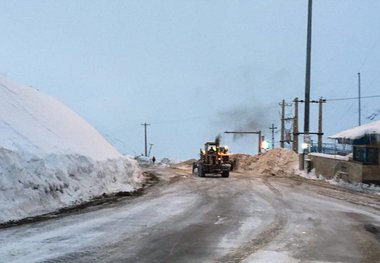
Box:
329;121;380;140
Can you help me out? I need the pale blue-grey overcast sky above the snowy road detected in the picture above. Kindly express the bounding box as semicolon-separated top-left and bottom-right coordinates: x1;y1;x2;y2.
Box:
0;0;380;159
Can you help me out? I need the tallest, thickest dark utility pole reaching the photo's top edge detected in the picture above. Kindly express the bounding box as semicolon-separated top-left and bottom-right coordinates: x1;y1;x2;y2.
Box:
304;0;313;139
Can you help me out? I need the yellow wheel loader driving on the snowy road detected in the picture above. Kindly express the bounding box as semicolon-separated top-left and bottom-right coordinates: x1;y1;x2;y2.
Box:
193;138;232;177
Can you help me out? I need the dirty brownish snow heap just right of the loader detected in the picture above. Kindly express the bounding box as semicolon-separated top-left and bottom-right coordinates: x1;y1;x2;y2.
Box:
232;148;298;176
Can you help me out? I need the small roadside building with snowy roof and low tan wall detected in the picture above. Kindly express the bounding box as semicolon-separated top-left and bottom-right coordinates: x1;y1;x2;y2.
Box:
309;121;380;184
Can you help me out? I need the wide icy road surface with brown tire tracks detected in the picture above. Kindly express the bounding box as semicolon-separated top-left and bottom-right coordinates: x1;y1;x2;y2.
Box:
0;168;380;263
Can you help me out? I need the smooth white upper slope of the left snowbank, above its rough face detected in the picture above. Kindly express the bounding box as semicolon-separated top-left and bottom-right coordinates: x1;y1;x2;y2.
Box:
0;78;120;160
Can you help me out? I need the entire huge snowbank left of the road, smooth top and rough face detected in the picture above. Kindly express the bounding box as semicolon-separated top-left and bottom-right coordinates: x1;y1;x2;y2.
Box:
0;78;142;223
